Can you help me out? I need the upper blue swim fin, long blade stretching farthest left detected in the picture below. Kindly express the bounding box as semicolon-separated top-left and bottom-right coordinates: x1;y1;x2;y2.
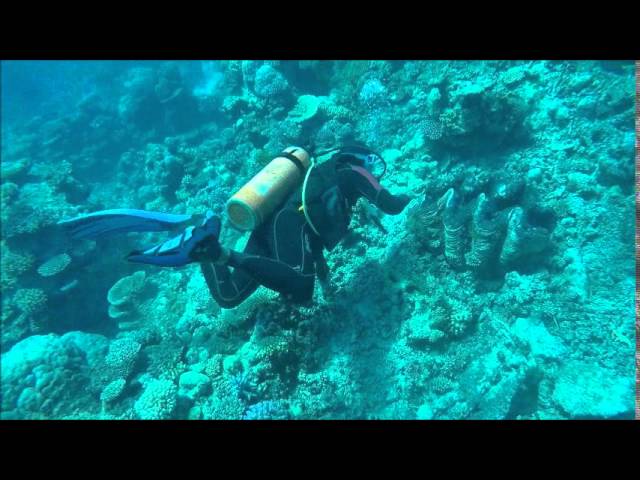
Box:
58;208;191;239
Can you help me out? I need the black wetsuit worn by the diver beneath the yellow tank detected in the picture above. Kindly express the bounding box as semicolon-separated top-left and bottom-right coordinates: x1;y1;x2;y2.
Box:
200;158;410;308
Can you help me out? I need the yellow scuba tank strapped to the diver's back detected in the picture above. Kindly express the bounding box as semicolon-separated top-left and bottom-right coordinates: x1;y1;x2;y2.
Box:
226;147;311;230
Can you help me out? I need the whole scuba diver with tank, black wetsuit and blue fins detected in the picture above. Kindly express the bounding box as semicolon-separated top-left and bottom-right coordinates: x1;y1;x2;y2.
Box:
59;146;411;308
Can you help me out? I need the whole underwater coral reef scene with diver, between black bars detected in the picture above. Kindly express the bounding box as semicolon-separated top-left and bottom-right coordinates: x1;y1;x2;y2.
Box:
0;60;636;420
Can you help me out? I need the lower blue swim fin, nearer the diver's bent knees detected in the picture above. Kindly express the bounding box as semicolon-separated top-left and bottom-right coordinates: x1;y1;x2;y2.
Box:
127;212;221;267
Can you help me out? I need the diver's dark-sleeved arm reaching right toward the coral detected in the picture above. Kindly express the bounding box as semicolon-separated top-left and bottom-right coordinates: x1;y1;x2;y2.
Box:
338;165;411;215
